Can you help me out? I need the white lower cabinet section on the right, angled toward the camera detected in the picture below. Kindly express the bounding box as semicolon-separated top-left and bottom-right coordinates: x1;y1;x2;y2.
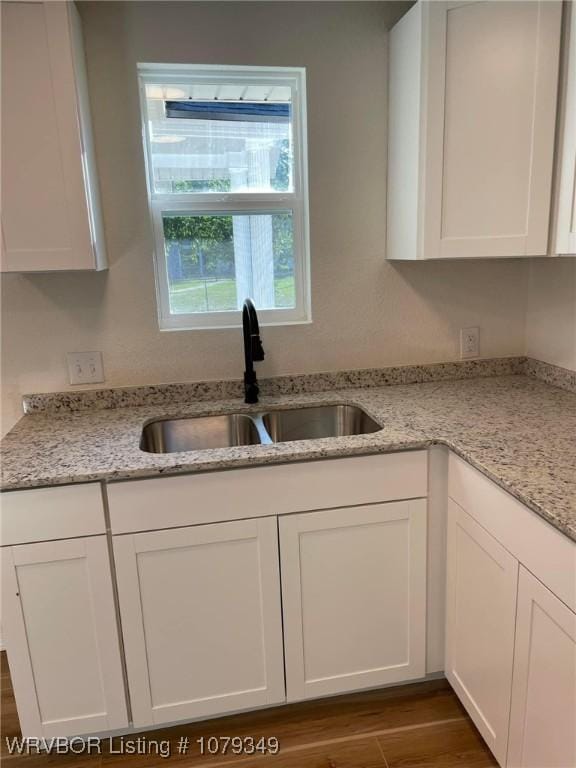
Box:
445;454;576;768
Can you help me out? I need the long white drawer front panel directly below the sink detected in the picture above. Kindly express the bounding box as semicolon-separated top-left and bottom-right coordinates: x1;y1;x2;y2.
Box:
107;451;427;534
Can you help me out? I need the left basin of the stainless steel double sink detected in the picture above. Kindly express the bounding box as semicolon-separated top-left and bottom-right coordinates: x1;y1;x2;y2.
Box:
140;413;261;453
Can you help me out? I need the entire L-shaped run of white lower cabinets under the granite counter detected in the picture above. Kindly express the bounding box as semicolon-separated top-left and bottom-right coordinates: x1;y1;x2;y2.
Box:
1;452;576;768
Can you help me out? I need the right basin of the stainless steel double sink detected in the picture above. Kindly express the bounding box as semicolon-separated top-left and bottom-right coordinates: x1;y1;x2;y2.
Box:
263;405;381;443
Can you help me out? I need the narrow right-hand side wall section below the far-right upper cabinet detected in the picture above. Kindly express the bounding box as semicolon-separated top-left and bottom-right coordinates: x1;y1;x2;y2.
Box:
526;258;576;371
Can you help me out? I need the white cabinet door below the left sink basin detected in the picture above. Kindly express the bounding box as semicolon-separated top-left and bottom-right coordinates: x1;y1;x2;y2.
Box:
114;517;285;727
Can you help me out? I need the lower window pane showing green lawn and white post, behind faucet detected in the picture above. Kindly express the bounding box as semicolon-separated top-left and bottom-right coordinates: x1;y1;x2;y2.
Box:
162;212;296;315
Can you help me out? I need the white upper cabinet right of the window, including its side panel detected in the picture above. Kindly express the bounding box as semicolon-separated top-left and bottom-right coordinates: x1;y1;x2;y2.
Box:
387;0;573;259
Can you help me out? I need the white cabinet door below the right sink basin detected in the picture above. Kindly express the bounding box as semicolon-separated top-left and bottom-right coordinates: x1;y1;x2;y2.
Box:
280;499;426;701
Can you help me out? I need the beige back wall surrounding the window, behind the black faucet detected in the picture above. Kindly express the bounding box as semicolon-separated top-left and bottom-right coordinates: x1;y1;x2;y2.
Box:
2;2;526;429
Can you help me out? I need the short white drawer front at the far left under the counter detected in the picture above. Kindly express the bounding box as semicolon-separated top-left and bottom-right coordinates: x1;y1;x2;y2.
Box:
0;483;106;546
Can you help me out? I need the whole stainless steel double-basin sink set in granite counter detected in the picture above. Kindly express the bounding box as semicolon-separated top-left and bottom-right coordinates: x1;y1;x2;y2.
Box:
140;405;382;453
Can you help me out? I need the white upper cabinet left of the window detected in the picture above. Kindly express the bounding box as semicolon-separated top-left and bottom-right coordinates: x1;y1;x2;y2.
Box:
2;2;106;272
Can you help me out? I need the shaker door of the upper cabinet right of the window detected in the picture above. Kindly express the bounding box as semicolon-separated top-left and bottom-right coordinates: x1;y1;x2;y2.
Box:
424;0;562;258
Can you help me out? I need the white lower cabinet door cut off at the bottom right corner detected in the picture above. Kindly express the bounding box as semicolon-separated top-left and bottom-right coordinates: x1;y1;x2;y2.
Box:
508;567;576;768
